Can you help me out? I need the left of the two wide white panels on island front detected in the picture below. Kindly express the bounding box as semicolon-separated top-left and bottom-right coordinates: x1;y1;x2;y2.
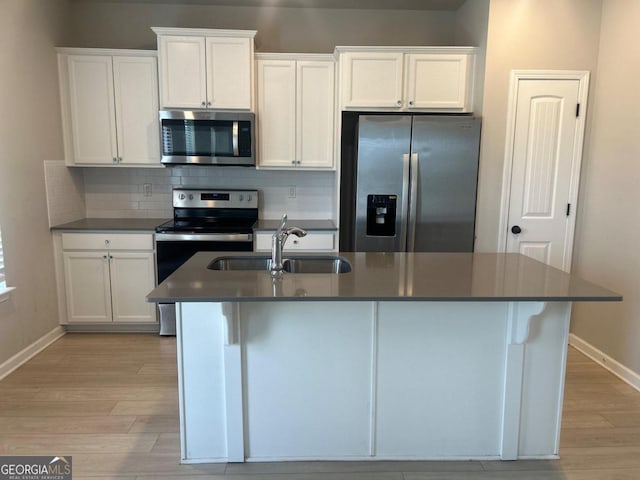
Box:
240;302;373;461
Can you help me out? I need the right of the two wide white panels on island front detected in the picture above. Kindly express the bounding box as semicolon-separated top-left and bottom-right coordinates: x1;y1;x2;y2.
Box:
376;302;508;459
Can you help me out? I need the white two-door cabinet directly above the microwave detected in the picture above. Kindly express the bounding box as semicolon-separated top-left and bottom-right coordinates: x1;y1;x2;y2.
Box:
153;28;256;110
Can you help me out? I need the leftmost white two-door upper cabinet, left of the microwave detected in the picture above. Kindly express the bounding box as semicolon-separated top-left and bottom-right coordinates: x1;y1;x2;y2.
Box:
58;49;160;166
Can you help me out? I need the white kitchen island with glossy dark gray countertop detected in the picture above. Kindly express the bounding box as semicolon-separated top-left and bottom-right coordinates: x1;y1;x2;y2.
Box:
148;252;621;463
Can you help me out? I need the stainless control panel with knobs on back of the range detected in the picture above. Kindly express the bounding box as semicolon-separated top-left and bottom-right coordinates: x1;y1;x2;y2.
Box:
173;188;258;208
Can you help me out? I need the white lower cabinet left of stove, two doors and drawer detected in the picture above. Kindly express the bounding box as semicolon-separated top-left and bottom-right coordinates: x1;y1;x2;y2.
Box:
62;233;156;324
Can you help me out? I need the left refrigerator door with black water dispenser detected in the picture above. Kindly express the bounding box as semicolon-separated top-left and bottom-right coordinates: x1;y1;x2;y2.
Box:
355;115;411;252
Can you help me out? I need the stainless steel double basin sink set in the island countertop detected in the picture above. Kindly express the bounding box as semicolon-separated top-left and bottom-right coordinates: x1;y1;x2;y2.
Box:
207;255;351;273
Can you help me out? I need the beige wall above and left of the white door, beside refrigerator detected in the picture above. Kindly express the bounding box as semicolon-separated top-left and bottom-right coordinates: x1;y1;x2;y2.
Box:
476;0;602;253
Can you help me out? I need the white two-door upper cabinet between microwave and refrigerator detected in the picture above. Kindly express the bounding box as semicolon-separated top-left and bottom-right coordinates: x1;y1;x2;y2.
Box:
257;54;335;169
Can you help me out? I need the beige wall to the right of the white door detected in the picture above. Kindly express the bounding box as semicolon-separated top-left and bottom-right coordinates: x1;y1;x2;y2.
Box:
572;0;640;375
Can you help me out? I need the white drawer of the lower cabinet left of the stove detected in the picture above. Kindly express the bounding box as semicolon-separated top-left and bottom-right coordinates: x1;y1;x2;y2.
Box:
62;233;153;251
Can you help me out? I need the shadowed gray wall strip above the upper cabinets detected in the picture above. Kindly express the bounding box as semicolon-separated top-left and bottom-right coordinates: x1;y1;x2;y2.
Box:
70;2;455;53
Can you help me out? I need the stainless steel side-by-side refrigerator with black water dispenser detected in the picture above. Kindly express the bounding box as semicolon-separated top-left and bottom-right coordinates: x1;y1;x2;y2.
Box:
340;114;480;252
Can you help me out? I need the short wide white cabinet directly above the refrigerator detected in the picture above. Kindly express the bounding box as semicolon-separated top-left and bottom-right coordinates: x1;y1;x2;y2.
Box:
336;47;476;113
